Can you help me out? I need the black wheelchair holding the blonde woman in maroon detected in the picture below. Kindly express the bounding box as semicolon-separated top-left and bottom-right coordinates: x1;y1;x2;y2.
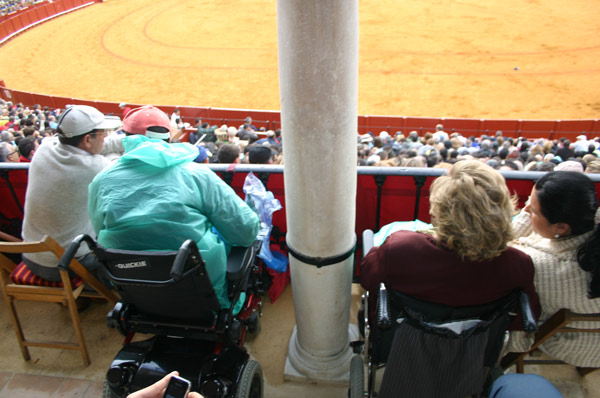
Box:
348;230;537;398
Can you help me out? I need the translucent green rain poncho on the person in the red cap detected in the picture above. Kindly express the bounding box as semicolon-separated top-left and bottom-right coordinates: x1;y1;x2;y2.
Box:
88;135;260;312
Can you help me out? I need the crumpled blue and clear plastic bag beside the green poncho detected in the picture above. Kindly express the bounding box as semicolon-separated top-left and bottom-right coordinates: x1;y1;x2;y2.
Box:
244;172;287;272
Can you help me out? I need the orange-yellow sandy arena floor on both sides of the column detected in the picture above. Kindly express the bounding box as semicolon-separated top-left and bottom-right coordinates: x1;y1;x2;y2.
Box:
0;0;600;119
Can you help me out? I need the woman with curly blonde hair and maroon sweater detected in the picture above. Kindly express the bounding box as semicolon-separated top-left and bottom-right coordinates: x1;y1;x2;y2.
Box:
360;161;539;328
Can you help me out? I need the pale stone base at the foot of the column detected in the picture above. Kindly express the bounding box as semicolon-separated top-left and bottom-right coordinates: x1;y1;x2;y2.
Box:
283;324;359;384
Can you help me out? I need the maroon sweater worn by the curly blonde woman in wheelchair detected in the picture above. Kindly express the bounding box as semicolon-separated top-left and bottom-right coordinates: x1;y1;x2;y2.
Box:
360;231;541;330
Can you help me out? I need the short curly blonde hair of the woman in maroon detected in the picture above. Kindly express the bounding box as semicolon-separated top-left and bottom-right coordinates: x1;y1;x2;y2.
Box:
429;160;516;261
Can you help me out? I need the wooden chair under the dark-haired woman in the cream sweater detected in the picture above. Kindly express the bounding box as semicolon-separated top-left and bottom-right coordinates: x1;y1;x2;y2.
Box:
501;308;600;376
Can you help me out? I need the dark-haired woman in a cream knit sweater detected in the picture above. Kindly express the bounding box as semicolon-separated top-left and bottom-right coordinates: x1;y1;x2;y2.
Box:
509;171;600;367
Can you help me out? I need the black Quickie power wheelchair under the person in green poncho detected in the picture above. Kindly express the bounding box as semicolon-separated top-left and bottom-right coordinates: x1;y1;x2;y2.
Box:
60;235;264;398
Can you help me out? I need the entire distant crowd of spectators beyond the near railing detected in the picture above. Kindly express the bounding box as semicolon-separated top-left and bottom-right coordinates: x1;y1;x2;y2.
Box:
0;100;600;173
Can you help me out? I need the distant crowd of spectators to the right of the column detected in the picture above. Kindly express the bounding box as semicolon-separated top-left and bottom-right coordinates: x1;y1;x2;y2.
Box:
358;125;600;173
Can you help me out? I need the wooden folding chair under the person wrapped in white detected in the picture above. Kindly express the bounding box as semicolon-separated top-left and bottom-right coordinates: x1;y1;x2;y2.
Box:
0;236;118;366
